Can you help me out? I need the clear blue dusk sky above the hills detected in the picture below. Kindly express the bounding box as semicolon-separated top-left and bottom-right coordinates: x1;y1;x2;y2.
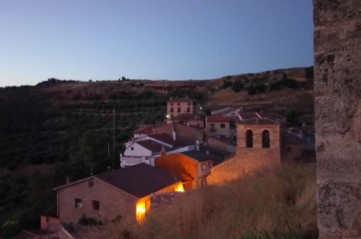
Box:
0;0;313;86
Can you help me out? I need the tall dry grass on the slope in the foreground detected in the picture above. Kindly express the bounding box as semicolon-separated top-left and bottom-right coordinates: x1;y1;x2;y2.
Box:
79;165;317;239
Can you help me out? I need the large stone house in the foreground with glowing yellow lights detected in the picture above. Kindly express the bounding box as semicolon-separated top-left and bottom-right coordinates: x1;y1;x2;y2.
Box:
54;164;184;223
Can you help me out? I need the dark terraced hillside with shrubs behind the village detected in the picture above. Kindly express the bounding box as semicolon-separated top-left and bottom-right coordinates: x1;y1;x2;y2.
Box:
0;68;313;239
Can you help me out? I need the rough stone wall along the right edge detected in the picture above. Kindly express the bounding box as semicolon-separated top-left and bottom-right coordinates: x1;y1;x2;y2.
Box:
313;0;361;239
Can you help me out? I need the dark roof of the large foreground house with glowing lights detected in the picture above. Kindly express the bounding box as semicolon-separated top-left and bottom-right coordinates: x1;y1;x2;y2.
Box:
95;164;179;198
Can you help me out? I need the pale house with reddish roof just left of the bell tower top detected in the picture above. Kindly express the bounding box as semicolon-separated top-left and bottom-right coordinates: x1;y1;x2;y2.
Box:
206;115;231;138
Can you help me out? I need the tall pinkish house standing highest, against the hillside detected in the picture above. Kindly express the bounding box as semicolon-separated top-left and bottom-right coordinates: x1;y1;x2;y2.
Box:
167;98;197;119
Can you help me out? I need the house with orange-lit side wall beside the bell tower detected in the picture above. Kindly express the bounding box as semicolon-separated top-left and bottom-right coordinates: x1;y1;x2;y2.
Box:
155;150;214;189
